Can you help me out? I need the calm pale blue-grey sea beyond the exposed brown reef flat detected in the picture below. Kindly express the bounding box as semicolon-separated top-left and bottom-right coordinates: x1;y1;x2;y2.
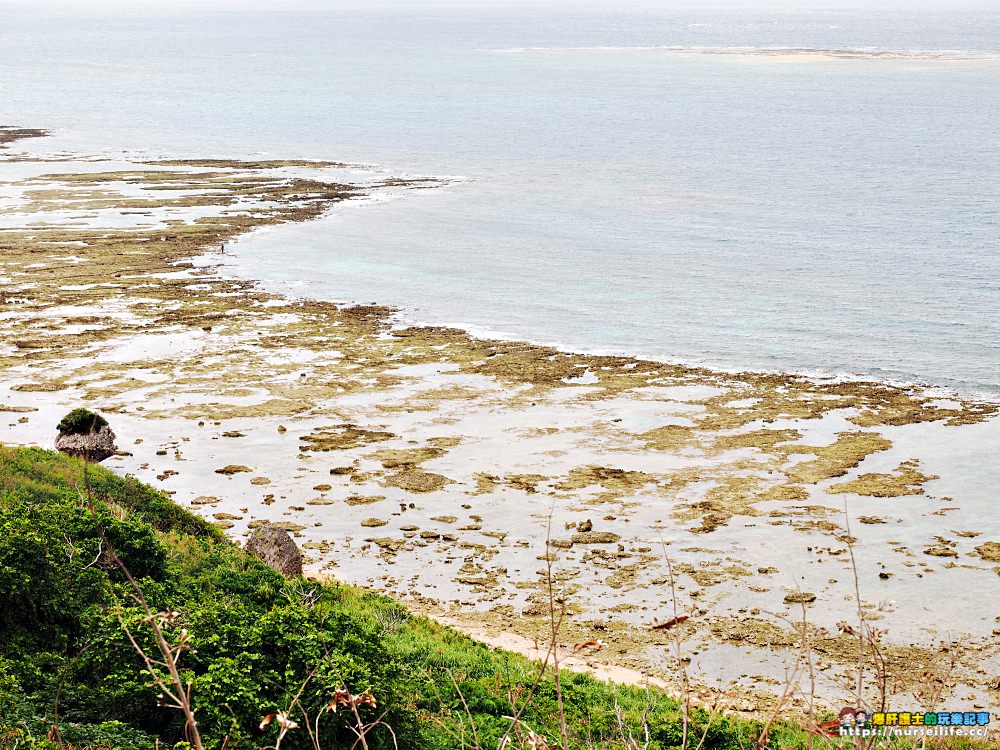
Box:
0;2;1000;397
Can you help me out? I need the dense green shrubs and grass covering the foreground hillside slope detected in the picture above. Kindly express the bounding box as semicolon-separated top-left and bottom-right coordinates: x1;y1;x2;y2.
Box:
0;446;816;750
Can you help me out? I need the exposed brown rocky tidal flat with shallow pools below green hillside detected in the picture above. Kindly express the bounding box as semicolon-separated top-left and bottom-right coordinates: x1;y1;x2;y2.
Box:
0;129;1000;712
